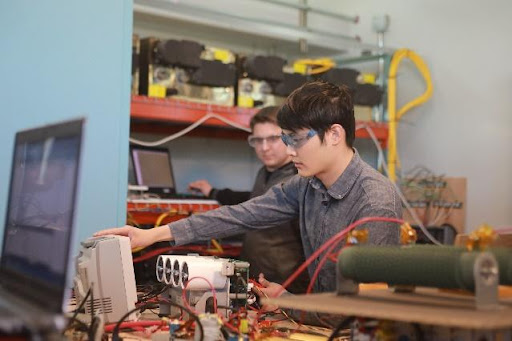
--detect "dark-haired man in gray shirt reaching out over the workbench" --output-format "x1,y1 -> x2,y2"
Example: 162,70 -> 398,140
98,81 -> 402,296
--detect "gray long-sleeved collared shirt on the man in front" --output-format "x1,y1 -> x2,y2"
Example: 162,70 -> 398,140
169,151 -> 402,292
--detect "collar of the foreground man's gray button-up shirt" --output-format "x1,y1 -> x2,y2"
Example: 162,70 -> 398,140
309,148 -> 363,200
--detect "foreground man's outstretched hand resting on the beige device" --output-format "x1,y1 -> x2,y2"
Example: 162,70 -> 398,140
94,225 -> 172,249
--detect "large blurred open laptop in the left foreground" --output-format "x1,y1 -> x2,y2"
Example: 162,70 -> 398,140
0,119 -> 84,339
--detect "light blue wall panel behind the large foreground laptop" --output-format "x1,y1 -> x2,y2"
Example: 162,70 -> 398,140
0,0 -> 133,245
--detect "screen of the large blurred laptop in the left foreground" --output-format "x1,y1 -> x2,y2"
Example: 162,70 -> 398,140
1,120 -> 83,311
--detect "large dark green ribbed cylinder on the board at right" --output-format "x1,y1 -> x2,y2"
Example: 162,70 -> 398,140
338,245 -> 512,290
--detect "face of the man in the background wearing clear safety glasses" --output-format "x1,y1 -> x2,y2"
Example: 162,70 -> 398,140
252,122 -> 291,171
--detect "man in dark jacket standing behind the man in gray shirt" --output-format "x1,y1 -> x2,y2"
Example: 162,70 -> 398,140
188,106 -> 308,293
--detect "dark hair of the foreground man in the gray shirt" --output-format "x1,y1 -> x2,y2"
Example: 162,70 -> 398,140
277,81 -> 356,147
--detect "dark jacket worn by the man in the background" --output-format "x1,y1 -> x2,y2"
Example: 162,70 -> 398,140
210,163 -> 309,293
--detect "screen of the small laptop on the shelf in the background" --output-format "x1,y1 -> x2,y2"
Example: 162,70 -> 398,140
132,147 -> 175,189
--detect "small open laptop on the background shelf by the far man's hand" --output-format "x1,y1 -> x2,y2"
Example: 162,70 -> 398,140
130,146 -> 205,200
